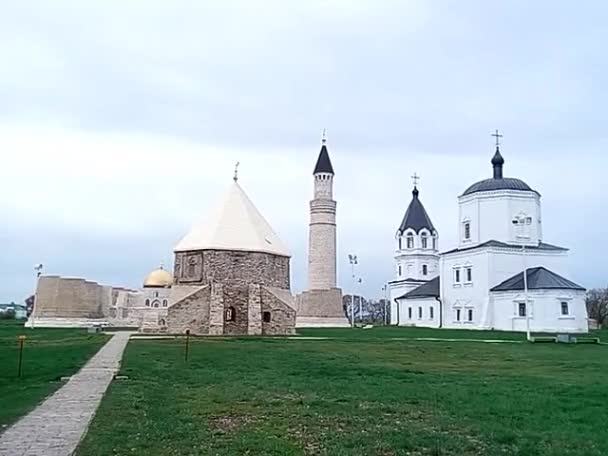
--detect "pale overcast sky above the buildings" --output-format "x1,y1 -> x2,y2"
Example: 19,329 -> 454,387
0,0 -> 608,301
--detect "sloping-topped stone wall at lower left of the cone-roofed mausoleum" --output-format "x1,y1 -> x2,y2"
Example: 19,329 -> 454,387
166,286 -> 211,334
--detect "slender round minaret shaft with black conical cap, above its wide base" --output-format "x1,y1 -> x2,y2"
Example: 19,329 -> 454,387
308,132 -> 336,290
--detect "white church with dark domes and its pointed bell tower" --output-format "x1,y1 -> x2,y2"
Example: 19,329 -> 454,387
389,145 -> 588,332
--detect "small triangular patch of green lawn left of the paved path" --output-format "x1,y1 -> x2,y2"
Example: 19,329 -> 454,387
0,320 -> 108,432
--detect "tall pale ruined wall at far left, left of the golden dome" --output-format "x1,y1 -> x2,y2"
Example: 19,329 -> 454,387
34,276 -> 107,318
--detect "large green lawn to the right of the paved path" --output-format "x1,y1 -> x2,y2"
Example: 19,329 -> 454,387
78,328 -> 608,456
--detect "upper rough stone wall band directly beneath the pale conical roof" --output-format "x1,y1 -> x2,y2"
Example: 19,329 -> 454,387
174,250 -> 290,289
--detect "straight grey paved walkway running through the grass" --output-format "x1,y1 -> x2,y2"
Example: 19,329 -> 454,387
0,332 -> 131,456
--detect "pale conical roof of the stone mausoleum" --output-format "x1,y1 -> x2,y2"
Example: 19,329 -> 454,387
175,181 -> 290,256
